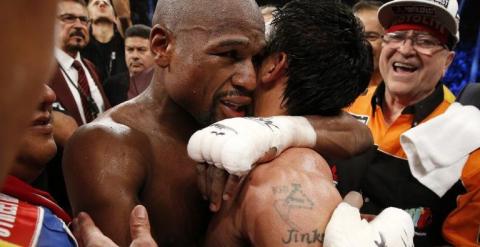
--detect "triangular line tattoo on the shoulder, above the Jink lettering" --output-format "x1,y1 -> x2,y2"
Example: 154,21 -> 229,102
272,184 -> 314,229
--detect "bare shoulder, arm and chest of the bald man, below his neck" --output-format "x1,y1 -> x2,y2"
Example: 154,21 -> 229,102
65,96 -> 207,246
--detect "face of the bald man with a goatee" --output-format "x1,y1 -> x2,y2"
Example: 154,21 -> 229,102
153,1 -> 265,124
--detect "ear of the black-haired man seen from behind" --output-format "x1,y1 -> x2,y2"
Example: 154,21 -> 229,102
259,52 -> 288,84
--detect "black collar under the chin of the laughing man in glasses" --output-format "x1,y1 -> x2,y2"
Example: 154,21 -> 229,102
371,81 -> 444,127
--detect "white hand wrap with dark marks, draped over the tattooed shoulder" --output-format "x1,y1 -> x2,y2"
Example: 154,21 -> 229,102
187,116 -> 317,176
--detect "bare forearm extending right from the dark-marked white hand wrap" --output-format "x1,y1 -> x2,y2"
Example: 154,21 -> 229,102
307,111 -> 373,159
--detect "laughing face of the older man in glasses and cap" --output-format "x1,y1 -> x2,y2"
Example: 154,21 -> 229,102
379,31 -> 454,105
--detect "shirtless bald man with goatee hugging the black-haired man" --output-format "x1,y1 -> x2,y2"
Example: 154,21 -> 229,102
63,0 -> 370,246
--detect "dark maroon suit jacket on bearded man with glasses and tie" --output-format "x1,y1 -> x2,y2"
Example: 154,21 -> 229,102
49,59 -> 110,126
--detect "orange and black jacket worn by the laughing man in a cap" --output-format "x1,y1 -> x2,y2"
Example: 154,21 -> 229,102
332,83 -> 480,246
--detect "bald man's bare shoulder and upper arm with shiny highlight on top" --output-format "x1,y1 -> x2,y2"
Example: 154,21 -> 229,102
63,124 -> 147,246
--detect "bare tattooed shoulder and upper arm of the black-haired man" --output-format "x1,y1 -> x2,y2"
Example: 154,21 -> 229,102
206,148 -> 342,247
